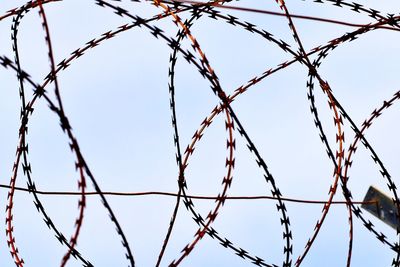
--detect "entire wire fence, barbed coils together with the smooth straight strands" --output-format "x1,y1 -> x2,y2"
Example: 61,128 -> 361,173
0,0 -> 400,267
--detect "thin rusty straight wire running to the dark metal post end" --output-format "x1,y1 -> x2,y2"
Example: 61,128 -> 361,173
0,184 -> 377,205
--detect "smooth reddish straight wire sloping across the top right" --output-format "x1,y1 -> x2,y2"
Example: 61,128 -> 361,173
170,0 -> 400,31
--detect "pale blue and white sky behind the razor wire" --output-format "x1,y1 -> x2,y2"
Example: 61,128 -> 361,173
0,0 -> 400,267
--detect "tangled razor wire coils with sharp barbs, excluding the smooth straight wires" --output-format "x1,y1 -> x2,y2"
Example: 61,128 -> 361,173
0,0 -> 400,267
